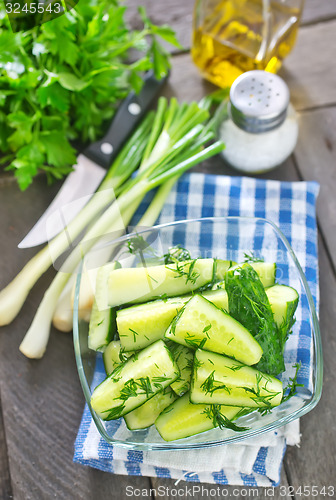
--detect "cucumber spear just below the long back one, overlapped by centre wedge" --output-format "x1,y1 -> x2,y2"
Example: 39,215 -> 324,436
117,290 -> 228,351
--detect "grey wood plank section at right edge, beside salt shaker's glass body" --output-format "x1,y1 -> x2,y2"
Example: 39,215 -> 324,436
295,108 -> 336,268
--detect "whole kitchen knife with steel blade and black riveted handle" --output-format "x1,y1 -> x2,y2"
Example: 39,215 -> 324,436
18,72 -> 167,248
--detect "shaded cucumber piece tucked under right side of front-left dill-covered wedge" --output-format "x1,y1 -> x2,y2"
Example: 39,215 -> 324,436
124,387 -> 177,431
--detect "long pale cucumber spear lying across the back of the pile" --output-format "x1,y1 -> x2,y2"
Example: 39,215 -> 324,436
108,259 -> 230,307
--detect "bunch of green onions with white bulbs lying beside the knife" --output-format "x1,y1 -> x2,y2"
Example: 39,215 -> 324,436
0,98 -> 224,358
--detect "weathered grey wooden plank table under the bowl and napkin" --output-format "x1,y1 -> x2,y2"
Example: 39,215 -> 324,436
0,0 -> 336,500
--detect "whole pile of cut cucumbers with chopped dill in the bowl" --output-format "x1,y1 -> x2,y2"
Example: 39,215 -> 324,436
88,247 -> 299,441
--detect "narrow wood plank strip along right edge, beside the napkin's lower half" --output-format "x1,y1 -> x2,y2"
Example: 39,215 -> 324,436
286,234 -> 336,492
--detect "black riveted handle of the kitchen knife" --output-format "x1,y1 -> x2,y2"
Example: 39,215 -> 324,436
83,71 -> 167,169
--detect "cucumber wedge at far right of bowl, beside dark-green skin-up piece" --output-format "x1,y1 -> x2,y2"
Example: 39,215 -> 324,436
266,285 -> 299,346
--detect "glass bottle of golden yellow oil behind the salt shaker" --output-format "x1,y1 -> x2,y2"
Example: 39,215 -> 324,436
192,0 -> 303,87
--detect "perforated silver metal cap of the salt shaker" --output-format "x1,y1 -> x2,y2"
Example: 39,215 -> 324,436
229,70 -> 289,134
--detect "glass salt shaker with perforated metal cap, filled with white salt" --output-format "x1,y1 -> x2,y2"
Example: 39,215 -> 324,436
219,70 -> 298,174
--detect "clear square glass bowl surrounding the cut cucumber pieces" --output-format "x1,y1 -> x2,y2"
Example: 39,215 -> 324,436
73,217 -> 323,450
